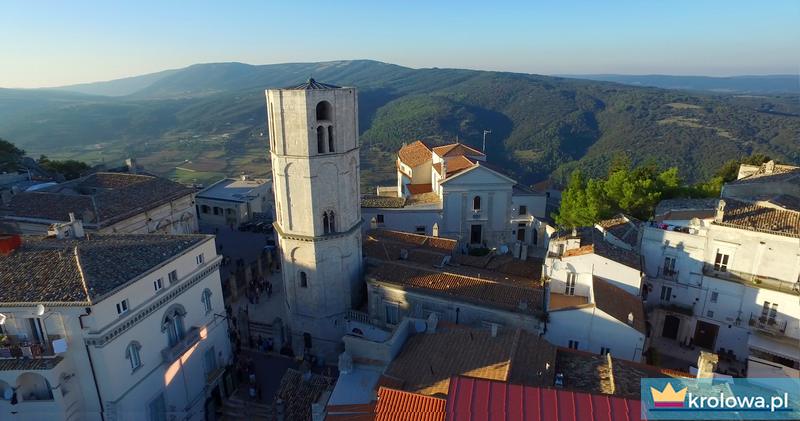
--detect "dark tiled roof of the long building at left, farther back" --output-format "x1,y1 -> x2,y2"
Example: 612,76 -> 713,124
0,172 -> 194,227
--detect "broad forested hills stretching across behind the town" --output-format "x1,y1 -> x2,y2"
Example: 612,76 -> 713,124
0,60 -> 800,186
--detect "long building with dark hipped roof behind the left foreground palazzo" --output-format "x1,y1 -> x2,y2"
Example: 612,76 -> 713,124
0,172 -> 198,235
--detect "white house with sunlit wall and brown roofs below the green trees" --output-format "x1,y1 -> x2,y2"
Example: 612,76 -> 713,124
544,215 -> 647,361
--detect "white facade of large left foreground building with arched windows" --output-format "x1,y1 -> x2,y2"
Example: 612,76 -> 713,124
0,237 -> 231,420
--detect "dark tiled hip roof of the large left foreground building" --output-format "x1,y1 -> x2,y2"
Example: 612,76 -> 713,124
0,234 -> 213,304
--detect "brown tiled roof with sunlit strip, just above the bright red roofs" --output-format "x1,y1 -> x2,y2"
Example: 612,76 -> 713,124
386,327 -> 555,395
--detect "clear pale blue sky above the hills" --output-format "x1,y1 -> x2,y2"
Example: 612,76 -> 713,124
0,0 -> 800,87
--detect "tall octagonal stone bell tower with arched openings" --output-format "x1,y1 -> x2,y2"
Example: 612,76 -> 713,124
266,79 -> 362,357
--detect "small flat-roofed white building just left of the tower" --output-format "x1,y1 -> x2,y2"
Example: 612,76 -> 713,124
195,175 -> 274,227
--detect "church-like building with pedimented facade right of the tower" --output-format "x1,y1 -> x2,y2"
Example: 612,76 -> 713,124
362,140 -> 552,254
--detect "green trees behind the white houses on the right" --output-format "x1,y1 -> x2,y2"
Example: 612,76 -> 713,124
553,154 -> 769,227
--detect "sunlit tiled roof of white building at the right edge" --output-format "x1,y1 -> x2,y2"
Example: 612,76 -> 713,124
715,199 -> 800,237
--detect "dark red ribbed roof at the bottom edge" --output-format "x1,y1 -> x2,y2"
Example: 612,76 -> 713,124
446,377 -> 641,421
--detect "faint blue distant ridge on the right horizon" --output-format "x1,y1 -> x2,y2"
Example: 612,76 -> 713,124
563,75 -> 800,94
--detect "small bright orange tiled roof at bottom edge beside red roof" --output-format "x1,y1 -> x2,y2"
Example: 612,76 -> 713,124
375,387 -> 447,421
